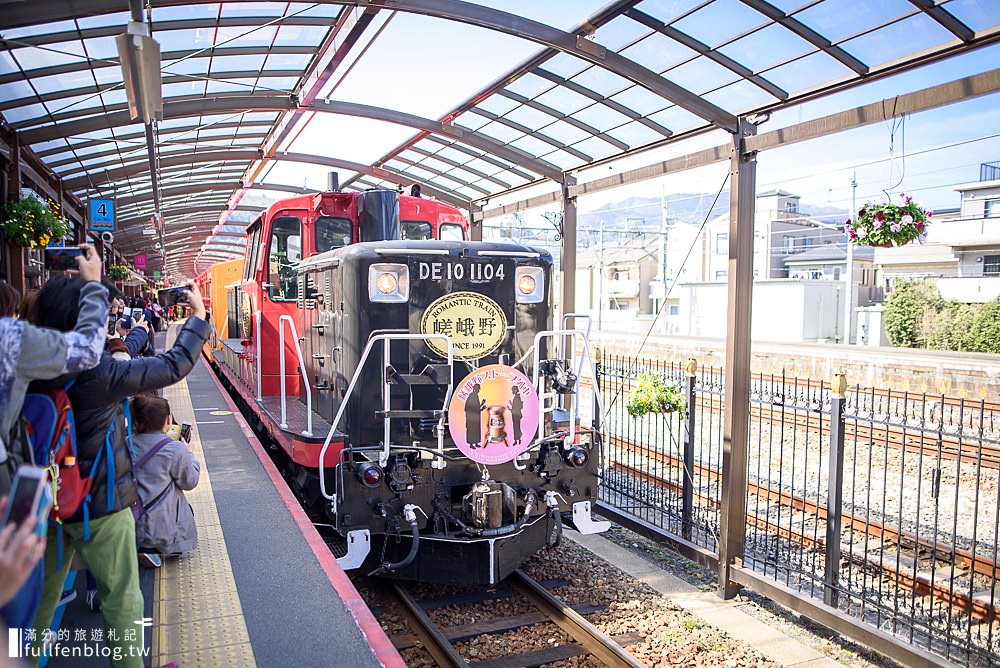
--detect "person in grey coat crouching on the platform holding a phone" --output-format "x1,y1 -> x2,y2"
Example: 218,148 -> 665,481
132,395 -> 201,568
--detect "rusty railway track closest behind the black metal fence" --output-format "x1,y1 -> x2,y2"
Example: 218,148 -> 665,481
609,437 -> 1000,622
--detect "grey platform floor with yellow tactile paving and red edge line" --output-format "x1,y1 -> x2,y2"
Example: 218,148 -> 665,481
42,332 -> 404,668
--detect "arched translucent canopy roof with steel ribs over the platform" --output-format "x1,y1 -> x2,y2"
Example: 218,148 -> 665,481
0,0 -> 1000,277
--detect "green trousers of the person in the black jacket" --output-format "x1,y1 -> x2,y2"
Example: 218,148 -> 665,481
31,508 -> 145,668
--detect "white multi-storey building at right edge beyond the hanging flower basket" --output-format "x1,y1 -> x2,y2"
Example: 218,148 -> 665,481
875,171 -> 1000,304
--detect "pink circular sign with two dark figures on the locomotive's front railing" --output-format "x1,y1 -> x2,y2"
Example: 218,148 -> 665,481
448,364 -> 538,464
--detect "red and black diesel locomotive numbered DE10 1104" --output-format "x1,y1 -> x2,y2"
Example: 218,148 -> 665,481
199,181 -> 607,584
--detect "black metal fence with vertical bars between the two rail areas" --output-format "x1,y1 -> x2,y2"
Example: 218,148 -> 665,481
597,355 -> 1000,665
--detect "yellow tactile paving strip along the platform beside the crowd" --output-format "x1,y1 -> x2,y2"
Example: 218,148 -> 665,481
152,366 -> 257,668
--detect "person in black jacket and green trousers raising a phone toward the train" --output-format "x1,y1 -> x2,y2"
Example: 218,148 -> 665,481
28,279 -> 210,668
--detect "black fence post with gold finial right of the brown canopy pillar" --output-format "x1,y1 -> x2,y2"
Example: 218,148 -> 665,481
823,371 -> 847,607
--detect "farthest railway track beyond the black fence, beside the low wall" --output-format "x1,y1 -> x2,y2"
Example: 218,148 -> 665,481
583,381 -> 1000,470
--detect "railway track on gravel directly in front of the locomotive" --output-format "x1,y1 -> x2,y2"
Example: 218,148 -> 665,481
384,569 -> 643,668
